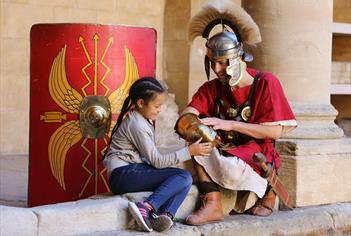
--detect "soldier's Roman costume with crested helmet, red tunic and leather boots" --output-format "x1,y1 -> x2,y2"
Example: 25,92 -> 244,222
176,1 -> 296,225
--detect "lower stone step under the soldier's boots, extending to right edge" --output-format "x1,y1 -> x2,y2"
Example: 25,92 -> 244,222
74,203 -> 351,236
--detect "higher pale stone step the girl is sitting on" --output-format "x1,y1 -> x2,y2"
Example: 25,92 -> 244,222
0,185 -> 198,236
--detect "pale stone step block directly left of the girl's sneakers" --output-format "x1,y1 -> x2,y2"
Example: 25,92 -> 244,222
32,196 -> 129,235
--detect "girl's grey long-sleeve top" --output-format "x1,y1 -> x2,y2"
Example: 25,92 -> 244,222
104,110 -> 191,174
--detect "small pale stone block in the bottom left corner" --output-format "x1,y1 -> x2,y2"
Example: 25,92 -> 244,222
0,205 -> 38,236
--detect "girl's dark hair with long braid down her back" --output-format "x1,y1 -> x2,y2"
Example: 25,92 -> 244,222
104,77 -> 165,158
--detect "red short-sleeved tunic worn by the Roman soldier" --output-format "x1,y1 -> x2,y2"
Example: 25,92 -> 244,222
189,68 -> 296,173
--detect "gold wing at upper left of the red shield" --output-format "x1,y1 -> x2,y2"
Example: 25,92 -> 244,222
49,45 -> 83,114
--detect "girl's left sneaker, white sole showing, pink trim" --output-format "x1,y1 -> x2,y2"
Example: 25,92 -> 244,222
128,202 -> 152,232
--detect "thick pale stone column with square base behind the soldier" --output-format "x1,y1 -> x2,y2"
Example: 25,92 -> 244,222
242,0 -> 351,207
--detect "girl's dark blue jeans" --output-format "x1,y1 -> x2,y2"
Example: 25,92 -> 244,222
109,163 -> 192,216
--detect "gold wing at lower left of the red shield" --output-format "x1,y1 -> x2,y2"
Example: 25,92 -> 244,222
48,120 -> 83,190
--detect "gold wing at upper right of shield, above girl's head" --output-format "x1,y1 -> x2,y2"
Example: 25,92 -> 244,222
108,46 -> 139,114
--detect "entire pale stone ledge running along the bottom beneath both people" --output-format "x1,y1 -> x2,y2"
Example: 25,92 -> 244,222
0,186 -> 351,236
